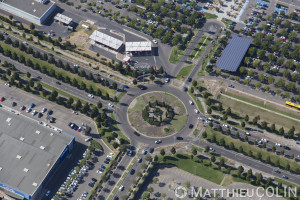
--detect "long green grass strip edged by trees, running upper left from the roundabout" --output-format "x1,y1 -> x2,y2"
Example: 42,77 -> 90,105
0,42 -> 116,96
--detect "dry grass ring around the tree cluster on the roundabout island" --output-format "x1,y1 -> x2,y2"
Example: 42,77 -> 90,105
128,92 -> 187,137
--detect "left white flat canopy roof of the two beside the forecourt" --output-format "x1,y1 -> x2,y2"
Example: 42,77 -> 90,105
90,30 -> 123,50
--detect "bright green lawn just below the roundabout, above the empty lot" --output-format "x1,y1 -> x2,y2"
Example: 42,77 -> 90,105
158,153 -> 224,185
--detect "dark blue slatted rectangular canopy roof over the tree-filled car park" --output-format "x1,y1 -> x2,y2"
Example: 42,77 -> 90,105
216,36 -> 252,72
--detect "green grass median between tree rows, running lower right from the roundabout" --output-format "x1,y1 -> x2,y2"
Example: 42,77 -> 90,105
206,127 -> 299,171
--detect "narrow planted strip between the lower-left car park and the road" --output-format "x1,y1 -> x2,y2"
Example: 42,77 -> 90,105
86,151 -> 124,199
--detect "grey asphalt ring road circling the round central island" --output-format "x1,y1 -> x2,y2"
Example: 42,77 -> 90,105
115,84 -> 201,146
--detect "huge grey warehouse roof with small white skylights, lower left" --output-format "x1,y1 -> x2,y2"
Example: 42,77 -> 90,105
0,107 -> 74,195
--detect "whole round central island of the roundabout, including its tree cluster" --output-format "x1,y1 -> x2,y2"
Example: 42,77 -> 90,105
128,92 -> 187,137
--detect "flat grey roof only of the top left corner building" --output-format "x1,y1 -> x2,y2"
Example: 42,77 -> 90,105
0,0 -> 55,18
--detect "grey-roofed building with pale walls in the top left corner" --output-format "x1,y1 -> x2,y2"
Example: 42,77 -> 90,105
0,0 -> 56,24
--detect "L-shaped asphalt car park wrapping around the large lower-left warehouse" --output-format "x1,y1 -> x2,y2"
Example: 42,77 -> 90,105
0,81 -> 111,199
